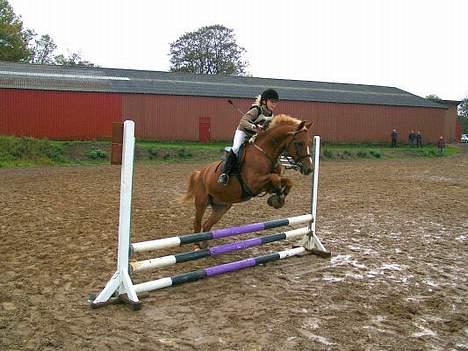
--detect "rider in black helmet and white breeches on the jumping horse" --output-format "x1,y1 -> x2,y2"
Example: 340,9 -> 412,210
218,89 -> 279,185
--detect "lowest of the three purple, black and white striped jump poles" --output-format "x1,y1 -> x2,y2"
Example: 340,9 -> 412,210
134,247 -> 306,294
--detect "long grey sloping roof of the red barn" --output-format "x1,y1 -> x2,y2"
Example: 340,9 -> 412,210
0,61 -> 447,108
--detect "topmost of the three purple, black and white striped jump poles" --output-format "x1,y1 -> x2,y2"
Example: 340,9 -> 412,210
131,214 -> 313,253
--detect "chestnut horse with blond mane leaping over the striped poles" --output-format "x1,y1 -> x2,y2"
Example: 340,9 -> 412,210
182,114 -> 313,248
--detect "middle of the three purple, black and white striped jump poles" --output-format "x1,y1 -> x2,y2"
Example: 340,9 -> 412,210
130,227 -> 309,273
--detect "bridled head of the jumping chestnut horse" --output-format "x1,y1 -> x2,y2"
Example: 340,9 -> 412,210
286,121 -> 313,175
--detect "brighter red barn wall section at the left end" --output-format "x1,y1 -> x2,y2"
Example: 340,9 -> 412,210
0,89 -> 122,140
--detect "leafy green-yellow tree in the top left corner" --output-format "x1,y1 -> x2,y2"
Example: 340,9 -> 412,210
0,0 -> 32,62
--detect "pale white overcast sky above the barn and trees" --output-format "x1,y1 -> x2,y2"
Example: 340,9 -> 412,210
9,0 -> 468,100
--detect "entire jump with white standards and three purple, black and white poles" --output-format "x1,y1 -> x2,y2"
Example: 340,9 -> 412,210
89,121 -> 331,309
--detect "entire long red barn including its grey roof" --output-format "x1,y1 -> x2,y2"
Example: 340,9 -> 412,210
0,62 -> 456,143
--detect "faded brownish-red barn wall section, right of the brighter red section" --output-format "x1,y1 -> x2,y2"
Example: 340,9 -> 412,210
122,94 -> 449,143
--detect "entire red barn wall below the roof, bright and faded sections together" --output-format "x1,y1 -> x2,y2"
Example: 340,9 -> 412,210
0,89 -> 448,143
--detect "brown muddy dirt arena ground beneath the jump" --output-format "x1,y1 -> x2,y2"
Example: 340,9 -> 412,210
0,152 -> 468,351
